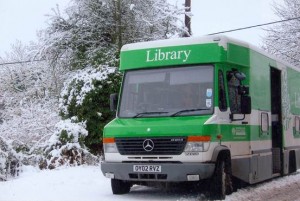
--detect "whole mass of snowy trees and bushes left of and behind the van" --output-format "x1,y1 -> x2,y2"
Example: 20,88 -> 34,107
0,0 -> 185,170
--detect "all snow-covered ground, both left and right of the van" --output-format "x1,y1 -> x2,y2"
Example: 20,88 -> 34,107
0,166 -> 300,201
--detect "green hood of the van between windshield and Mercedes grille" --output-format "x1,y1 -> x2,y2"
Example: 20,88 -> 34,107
104,115 -> 210,137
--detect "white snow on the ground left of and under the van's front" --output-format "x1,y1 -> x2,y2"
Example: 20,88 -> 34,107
0,166 -> 199,201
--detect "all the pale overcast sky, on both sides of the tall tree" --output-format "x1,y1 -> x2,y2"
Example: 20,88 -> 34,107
0,0 -> 282,56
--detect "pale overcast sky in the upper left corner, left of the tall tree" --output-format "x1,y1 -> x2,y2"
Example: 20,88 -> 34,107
0,0 -> 69,57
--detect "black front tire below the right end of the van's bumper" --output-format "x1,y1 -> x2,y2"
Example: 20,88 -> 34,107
210,159 -> 233,200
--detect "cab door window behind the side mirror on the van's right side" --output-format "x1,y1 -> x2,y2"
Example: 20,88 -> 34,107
227,71 -> 241,114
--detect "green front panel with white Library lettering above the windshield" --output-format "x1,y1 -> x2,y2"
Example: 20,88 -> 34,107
120,43 -> 226,71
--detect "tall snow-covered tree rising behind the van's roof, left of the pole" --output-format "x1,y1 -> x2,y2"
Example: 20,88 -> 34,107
40,0 -> 185,69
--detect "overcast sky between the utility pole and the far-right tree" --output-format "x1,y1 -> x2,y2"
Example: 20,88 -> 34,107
192,0 -> 282,46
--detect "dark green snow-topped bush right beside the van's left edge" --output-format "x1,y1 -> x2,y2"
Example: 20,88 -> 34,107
59,66 -> 121,154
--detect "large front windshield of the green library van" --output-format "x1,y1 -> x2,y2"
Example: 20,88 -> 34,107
119,66 -> 214,118
